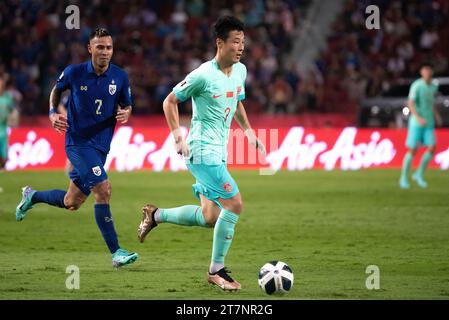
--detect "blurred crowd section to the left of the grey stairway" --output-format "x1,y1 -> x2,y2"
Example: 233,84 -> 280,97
0,0 -> 304,115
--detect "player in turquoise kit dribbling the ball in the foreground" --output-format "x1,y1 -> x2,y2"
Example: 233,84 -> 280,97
138,16 -> 265,291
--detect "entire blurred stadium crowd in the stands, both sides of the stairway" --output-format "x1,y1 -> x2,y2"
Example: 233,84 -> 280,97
0,0 -> 449,115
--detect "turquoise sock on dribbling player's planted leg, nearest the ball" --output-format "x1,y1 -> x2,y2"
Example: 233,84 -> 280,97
211,209 -> 239,272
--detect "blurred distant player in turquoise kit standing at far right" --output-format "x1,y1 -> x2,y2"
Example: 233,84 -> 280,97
399,64 -> 442,189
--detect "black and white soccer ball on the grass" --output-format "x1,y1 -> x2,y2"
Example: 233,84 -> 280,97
259,261 -> 293,294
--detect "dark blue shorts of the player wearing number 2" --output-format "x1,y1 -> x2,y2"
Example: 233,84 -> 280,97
65,146 -> 108,196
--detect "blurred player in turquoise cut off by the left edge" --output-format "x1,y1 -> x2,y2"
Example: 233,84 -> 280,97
0,75 -> 19,179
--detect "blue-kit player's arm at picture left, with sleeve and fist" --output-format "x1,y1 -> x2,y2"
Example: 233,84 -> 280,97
48,66 -> 72,133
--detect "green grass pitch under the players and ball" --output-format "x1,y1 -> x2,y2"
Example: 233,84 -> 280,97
0,170 -> 449,300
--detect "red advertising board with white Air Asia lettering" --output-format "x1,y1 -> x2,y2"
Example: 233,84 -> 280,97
6,126 -> 449,171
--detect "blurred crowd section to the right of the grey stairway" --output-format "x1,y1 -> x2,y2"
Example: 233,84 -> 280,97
310,0 -> 449,112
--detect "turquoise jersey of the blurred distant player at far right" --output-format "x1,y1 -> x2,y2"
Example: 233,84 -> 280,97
408,78 -> 438,128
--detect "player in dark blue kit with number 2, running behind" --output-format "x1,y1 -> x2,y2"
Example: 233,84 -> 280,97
16,28 -> 139,268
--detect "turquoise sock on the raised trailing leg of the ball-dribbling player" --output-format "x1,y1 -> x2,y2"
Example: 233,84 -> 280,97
156,205 -> 209,227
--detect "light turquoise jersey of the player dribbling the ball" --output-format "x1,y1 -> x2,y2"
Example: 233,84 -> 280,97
173,59 -> 246,165
